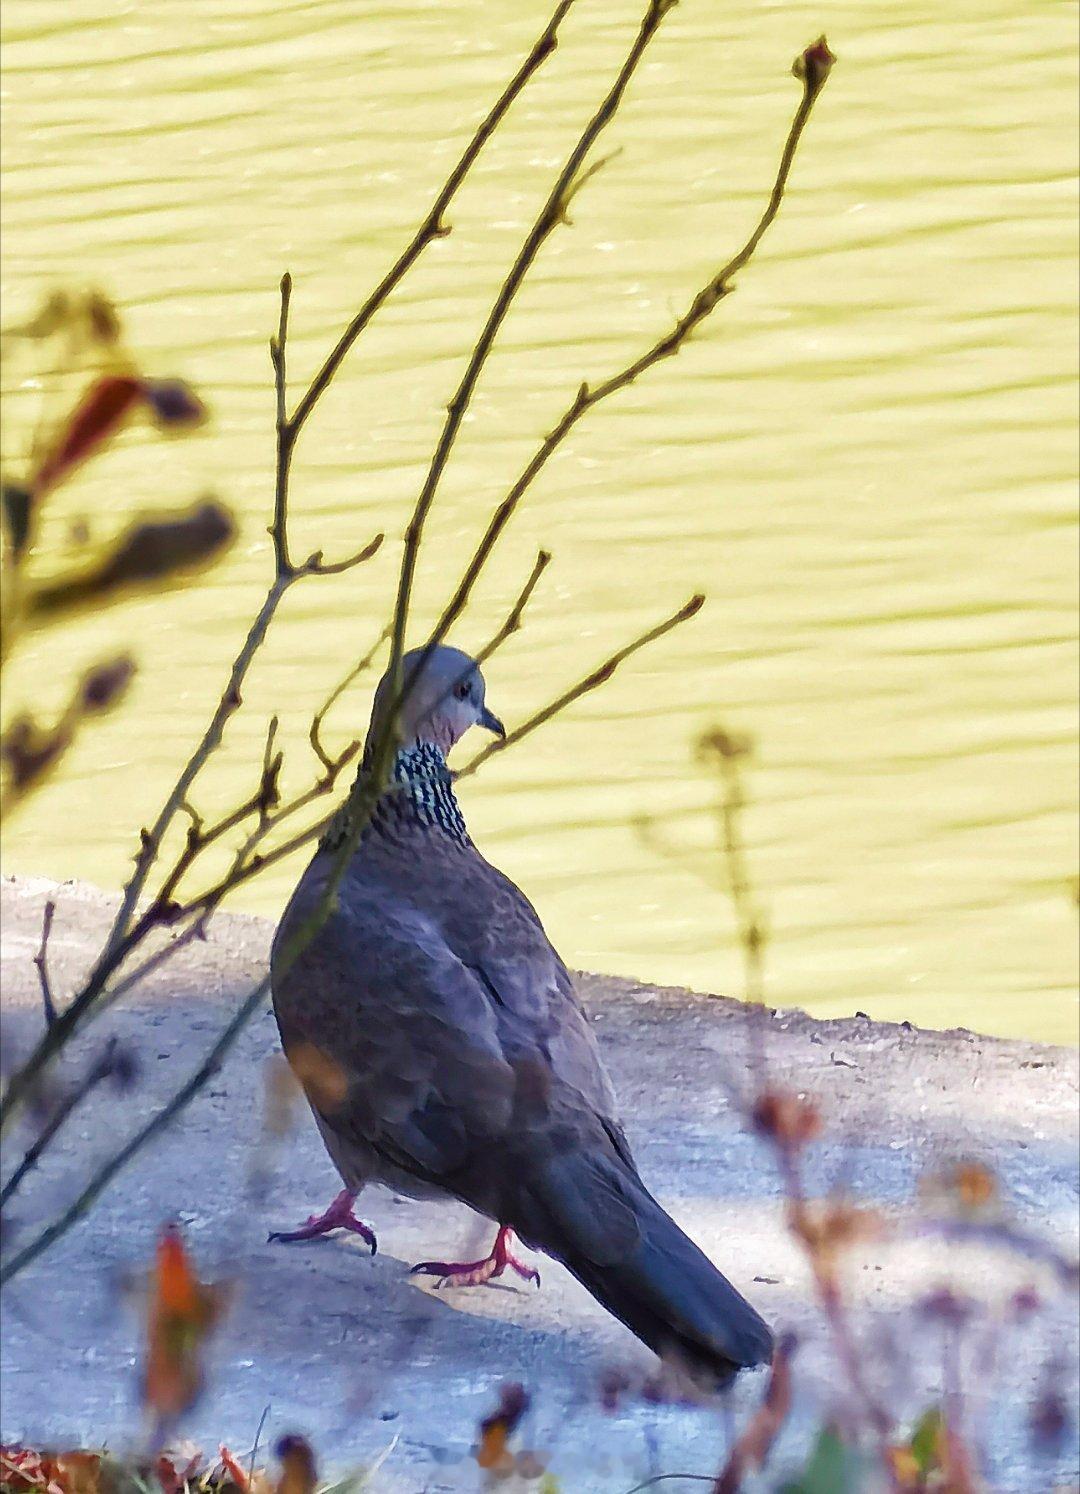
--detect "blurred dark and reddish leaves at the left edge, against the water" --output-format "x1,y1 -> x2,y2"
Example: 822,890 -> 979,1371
0,291 -> 236,813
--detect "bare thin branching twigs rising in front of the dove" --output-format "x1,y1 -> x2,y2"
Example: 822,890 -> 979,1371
0,0 -> 832,1282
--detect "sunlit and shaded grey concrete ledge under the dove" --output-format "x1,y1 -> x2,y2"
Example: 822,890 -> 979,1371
0,878 -> 1077,1494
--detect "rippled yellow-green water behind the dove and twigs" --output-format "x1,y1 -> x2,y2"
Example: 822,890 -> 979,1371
3,0 -> 1079,1040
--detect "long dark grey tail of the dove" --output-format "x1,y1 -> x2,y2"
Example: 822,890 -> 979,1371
517,1152 -> 774,1386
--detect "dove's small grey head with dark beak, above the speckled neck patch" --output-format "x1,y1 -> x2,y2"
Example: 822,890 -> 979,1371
367,644 -> 506,756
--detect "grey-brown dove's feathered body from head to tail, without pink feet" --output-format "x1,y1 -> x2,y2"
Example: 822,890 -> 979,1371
272,647 -> 772,1382
